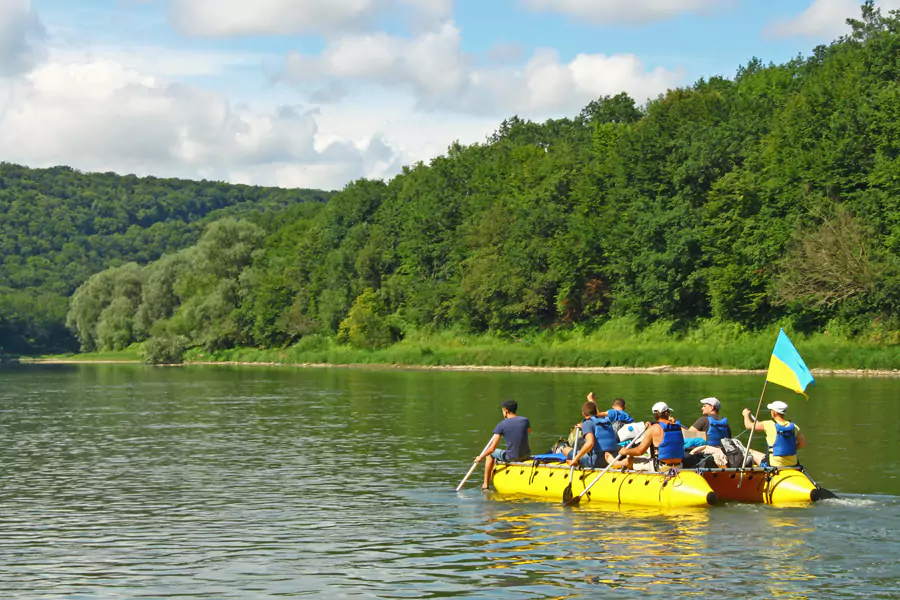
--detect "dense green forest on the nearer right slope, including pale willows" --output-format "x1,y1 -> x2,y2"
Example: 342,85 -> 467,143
45,2 -> 900,361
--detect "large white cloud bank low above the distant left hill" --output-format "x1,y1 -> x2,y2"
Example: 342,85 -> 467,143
0,59 -> 398,188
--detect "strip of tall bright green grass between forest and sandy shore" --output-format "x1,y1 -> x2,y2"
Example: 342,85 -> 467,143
185,319 -> 900,370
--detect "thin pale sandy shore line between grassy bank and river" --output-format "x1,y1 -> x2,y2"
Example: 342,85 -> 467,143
19,358 -> 900,377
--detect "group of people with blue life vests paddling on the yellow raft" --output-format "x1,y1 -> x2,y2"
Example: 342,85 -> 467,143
475,392 -> 806,490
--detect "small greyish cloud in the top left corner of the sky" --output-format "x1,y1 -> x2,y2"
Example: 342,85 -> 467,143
0,0 -> 44,78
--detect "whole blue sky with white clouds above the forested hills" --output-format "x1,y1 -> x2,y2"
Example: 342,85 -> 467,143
0,0 -> 900,189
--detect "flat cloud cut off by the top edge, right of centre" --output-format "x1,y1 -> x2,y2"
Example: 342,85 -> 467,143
519,0 -> 724,24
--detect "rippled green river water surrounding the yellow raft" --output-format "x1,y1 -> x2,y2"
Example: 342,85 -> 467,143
0,365 -> 900,600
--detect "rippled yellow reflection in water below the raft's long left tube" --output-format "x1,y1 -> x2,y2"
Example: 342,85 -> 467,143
478,496 -> 709,592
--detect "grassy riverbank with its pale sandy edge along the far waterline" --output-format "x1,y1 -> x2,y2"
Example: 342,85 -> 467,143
23,325 -> 900,377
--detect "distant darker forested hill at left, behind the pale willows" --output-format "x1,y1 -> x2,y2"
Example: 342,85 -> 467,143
0,163 -> 330,352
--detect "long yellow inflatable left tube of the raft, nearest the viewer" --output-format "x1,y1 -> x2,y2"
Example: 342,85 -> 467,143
493,462 -> 716,508
